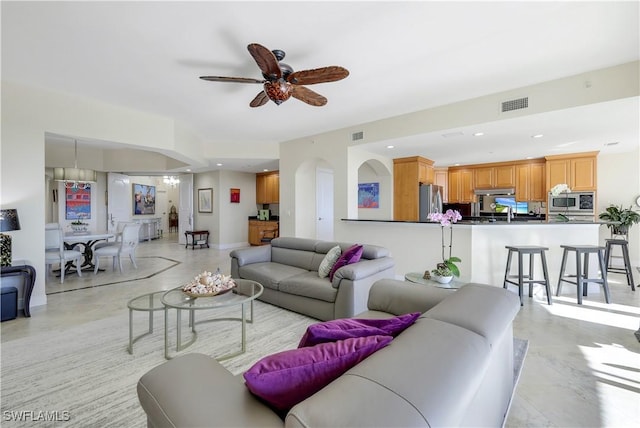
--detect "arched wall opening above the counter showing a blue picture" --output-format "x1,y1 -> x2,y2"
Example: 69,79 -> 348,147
358,159 -> 393,220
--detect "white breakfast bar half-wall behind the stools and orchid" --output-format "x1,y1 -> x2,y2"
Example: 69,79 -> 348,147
336,219 -> 602,292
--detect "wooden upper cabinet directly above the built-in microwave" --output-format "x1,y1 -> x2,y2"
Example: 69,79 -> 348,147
545,152 -> 598,191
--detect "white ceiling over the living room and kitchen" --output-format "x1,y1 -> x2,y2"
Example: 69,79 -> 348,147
2,1 -> 640,171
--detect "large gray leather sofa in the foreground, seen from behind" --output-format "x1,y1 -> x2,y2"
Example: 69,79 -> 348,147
138,280 -> 520,428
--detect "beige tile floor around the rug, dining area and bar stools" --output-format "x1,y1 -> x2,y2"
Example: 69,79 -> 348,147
0,233 -> 640,427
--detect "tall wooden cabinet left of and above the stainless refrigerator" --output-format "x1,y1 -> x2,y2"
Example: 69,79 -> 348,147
393,156 -> 434,221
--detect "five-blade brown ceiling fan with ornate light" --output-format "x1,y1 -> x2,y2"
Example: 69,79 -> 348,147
200,43 -> 349,107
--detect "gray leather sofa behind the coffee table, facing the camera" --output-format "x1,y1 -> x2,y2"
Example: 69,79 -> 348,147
230,237 -> 395,321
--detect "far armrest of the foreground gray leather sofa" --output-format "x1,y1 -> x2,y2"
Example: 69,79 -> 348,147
367,279 -> 454,315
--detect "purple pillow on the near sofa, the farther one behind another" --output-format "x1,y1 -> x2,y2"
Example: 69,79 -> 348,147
298,312 -> 421,348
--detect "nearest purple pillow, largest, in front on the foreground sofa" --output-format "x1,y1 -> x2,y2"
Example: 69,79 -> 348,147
243,336 -> 393,412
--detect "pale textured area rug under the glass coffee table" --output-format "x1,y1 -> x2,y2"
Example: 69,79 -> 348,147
1,301 -> 528,428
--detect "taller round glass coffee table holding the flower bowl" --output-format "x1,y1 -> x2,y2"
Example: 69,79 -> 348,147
161,278 -> 264,361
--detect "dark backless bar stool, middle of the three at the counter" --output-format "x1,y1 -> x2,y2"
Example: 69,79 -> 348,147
556,245 -> 609,305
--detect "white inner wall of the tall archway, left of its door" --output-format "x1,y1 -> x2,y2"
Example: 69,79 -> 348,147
294,158 -> 334,239
